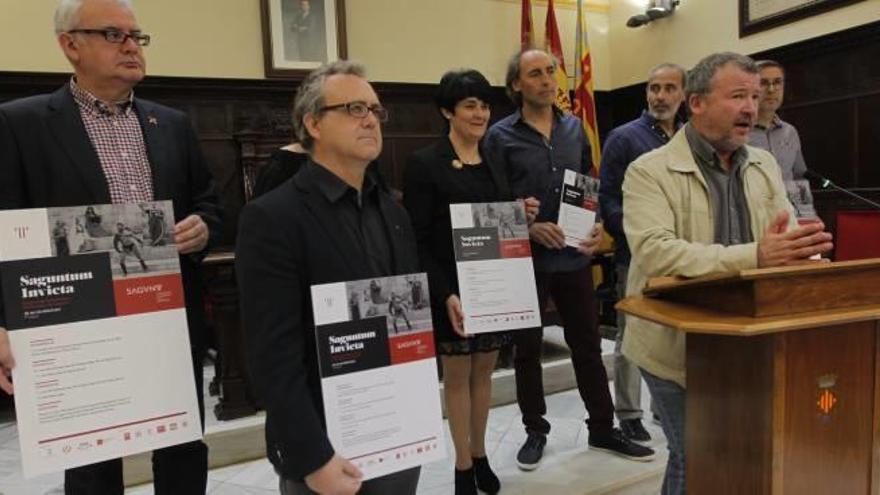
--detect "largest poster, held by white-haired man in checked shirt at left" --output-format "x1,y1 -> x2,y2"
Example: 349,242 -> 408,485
0,201 -> 202,477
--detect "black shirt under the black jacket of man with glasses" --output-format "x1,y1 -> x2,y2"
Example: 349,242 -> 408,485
306,162 -> 393,277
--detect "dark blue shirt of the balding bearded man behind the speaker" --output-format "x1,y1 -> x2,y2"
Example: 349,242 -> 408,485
599,111 -> 681,266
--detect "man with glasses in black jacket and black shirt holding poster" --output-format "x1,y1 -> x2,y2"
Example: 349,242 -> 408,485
236,62 -> 419,495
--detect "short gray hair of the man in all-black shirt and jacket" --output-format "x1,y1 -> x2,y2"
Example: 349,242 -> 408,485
293,60 -> 367,151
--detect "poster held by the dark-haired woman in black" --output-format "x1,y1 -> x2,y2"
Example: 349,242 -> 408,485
449,201 -> 541,334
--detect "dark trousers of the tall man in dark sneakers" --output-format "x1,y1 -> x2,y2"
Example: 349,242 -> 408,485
513,267 -> 614,436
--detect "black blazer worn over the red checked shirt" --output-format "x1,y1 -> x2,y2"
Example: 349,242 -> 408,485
0,86 -> 220,349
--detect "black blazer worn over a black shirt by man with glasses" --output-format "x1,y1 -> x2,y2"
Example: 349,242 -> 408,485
235,161 -> 418,480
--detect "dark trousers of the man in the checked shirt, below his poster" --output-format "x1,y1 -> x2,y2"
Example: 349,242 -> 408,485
64,350 -> 208,495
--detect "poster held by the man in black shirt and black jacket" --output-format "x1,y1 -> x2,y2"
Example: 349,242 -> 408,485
312,273 -> 446,479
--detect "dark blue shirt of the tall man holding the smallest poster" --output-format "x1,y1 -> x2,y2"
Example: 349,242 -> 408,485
483,108 -> 592,272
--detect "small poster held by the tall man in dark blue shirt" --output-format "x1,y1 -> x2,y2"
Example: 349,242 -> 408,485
556,170 -> 599,248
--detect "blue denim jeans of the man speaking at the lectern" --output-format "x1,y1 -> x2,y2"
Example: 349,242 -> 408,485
642,369 -> 686,495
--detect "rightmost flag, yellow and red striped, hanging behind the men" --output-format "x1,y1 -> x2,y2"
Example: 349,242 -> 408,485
573,0 -> 602,170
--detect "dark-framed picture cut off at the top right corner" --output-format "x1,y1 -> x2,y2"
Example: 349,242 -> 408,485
739,0 -> 864,38
